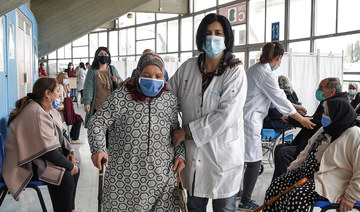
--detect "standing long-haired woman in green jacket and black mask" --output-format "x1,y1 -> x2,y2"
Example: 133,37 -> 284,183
83,47 -> 122,128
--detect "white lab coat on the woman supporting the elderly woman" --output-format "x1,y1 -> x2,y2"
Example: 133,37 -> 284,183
169,58 -> 247,199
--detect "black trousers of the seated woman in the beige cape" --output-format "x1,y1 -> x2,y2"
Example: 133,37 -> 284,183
48,169 -> 80,212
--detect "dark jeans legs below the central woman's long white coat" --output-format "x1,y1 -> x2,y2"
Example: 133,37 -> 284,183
187,194 -> 236,212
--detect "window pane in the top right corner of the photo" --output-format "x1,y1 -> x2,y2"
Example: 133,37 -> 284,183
338,0 -> 360,32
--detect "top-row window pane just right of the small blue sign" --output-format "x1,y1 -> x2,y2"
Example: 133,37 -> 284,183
289,0 -> 311,39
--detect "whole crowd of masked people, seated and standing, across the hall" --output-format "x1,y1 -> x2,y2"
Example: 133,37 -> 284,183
3,13 -> 360,212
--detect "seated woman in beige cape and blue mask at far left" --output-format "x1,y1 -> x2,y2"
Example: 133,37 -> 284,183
2,77 -> 79,212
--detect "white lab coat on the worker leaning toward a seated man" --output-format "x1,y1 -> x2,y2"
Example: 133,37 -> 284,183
244,63 -> 296,162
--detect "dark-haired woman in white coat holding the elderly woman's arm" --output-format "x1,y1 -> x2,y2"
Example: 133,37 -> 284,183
169,13 -> 247,212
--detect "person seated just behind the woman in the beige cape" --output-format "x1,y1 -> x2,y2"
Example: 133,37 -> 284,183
57,73 -> 82,143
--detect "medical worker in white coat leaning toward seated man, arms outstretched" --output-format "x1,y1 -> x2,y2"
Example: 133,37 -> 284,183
238,42 -> 315,210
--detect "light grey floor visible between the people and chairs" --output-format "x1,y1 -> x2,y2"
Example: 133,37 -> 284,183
0,106 -> 324,212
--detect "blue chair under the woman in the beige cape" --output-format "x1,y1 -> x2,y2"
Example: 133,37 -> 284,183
0,131 -> 47,212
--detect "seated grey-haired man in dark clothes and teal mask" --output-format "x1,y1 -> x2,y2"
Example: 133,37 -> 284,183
272,77 -> 347,180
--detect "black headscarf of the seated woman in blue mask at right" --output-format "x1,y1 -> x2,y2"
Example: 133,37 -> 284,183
324,97 -> 356,142
